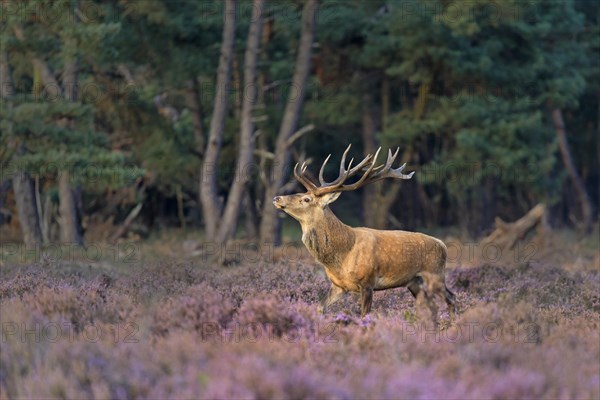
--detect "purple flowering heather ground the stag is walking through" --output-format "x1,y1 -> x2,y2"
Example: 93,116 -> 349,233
0,227 -> 600,399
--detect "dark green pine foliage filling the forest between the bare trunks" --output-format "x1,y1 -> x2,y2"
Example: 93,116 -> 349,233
0,0 -> 600,233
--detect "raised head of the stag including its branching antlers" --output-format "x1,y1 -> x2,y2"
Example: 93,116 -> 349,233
273,145 -> 414,223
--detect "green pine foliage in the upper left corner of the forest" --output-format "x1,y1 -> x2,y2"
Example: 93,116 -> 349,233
1,1 -> 143,191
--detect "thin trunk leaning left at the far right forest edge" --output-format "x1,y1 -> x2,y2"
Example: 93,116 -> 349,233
552,108 -> 593,233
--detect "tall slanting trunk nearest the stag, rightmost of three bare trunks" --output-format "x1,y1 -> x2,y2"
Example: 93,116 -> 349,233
260,0 -> 318,244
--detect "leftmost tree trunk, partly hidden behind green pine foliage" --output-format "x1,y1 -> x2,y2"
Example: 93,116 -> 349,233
0,51 -> 42,247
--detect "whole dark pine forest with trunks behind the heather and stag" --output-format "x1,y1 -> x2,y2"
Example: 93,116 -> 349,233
0,0 -> 600,250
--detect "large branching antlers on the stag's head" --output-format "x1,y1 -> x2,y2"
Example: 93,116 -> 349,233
294,145 -> 414,196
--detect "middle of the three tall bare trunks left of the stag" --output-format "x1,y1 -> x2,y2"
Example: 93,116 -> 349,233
216,0 -> 264,245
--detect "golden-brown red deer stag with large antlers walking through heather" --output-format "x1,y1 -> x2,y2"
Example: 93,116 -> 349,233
273,146 -> 455,320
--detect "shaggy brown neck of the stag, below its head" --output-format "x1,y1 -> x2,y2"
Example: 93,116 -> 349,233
302,207 -> 355,268
